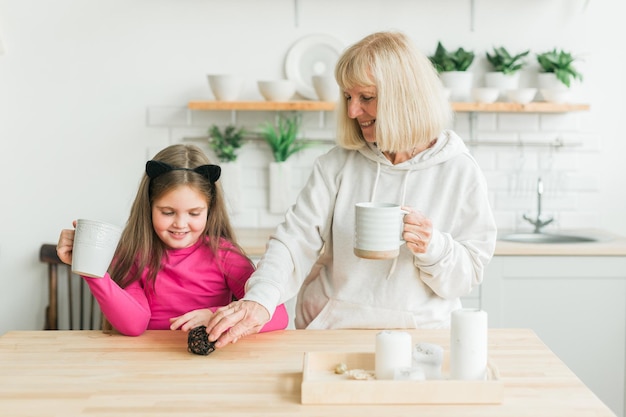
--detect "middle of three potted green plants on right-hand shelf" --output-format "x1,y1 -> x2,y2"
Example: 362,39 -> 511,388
485,46 -> 530,94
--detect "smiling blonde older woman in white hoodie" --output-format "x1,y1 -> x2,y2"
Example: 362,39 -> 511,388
207,32 -> 496,347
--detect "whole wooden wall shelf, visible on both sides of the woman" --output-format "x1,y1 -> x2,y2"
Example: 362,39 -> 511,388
188,100 -> 589,113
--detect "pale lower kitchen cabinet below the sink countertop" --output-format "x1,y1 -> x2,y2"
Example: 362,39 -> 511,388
481,256 -> 626,417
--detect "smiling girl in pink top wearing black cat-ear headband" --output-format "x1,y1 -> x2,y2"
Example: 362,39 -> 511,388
57,145 -> 288,336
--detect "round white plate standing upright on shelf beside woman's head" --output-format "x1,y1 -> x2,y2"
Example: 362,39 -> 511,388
285,35 -> 344,100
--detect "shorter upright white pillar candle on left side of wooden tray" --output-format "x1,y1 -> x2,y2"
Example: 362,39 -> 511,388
375,330 -> 413,379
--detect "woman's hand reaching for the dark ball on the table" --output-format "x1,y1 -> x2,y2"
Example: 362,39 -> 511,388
207,300 -> 271,348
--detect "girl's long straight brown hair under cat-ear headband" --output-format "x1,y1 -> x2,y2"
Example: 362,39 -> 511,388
110,144 -> 243,288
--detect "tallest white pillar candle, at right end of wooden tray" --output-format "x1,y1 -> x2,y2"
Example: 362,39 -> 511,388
450,308 -> 487,380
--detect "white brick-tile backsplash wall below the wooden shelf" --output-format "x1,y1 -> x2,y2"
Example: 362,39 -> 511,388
146,106 -> 600,230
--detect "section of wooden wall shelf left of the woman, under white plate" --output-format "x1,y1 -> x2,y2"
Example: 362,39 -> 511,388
188,100 -> 335,111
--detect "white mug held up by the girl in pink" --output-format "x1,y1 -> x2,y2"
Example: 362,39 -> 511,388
72,219 -> 122,278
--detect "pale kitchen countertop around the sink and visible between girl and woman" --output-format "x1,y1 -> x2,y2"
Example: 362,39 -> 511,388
235,228 -> 626,258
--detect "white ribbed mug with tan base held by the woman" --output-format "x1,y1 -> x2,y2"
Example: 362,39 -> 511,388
354,203 -> 408,259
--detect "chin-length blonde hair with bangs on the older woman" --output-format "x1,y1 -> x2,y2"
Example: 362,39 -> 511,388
335,32 -> 452,153
